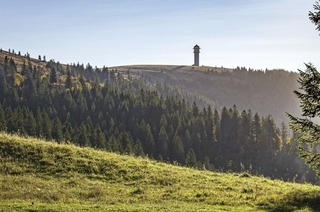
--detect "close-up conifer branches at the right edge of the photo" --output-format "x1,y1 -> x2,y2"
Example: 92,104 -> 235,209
289,1 -> 320,176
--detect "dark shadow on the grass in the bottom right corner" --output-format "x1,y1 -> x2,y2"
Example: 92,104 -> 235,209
264,191 -> 320,212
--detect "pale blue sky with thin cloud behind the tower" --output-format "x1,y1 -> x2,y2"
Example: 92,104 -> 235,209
0,0 -> 320,71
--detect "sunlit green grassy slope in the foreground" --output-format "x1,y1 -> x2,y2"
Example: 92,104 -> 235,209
0,133 -> 320,211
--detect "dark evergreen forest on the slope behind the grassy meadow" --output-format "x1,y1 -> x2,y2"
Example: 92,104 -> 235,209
0,51 -> 317,183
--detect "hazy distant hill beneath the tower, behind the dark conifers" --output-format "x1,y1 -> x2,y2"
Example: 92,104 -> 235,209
113,65 -> 301,123
